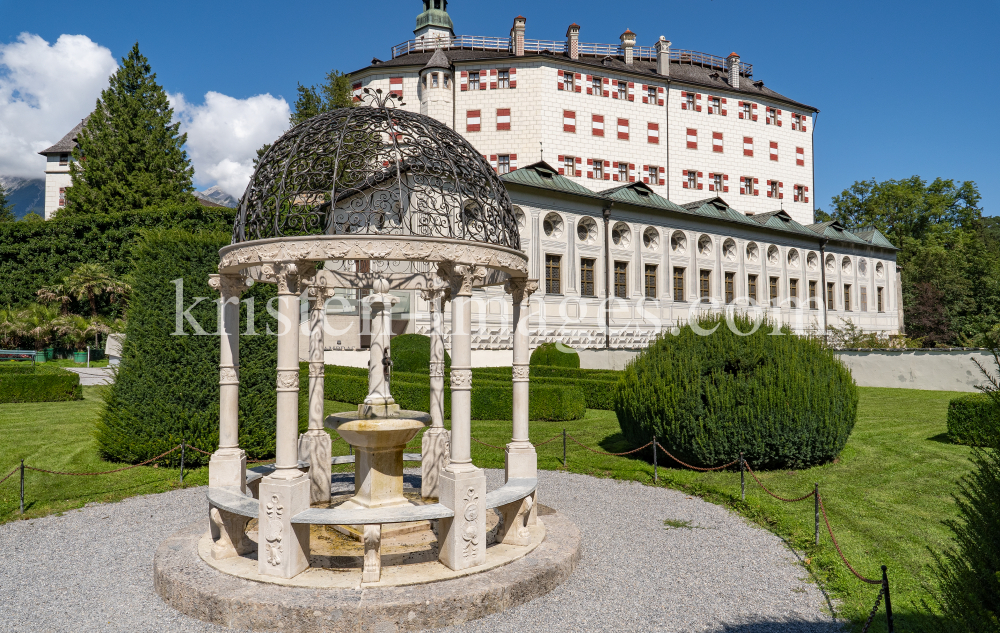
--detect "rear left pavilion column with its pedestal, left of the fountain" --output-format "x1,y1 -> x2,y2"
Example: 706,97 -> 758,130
299,278 -> 334,503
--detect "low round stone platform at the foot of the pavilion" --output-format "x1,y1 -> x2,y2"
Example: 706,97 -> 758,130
153,505 -> 581,633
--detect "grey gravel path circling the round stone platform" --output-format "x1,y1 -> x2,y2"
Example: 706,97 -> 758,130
0,471 -> 841,633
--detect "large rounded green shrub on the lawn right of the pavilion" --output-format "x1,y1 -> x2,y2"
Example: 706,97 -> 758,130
614,314 -> 858,468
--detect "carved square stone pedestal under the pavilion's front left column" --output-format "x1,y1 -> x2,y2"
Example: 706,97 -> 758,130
257,475 -> 310,578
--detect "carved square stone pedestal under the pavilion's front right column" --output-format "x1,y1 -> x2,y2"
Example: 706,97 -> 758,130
438,468 -> 486,570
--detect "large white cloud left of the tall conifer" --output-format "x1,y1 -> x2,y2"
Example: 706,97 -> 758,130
0,33 -> 118,178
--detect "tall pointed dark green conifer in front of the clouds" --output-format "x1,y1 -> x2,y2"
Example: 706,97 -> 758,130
60,43 -> 194,214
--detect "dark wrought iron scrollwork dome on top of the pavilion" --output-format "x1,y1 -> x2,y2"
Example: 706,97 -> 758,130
233,89 -> 521,250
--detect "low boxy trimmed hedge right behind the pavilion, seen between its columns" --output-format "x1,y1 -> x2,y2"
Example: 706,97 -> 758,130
324,366 -> 586,421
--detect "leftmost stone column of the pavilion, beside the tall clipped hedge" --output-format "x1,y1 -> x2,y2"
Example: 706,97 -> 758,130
208,275 -> 247,494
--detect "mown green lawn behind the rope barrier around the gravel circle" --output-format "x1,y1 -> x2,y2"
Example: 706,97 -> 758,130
0,387 -> 969,631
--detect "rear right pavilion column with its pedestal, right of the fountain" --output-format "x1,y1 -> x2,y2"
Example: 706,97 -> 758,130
420,286 -> 451,498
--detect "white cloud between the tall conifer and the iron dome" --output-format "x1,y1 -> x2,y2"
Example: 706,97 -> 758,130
170,92 -> 291,198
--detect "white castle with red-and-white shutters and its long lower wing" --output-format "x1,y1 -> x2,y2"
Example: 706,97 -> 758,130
332,0 -> 902,351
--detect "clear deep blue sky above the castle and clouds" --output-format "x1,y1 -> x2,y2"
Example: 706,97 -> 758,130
0,0 -> 1000,215
